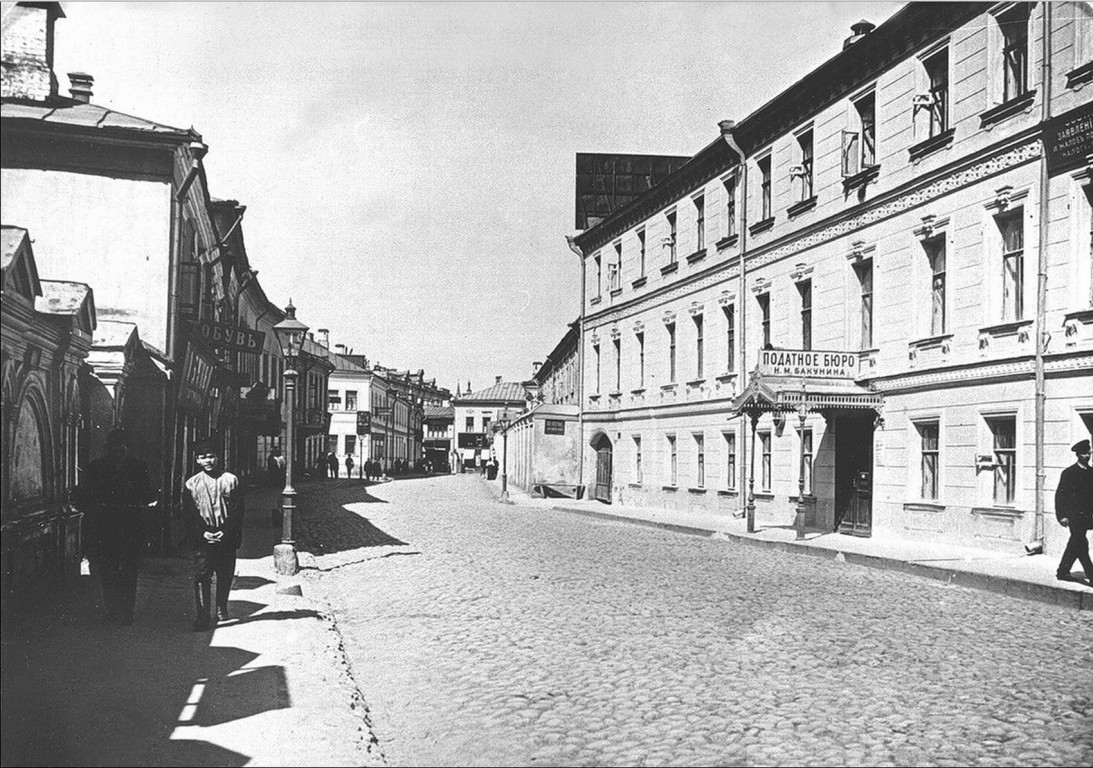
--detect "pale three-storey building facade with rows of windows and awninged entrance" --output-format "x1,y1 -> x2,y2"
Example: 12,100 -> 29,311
575,3 -> 1093,551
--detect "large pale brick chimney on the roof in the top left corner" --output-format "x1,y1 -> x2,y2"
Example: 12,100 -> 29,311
0,2 -> 64,102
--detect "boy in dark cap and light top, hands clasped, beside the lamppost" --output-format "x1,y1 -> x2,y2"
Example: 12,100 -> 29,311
183,439 -> 244,631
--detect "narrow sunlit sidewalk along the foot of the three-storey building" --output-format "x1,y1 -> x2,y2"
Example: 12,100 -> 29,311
483,478 -> 1093,611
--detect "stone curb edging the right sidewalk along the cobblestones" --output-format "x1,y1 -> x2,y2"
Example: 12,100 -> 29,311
551,506 -> 1093,611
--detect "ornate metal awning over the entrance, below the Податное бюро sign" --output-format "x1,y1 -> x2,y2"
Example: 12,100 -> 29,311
732,371 -> 884,414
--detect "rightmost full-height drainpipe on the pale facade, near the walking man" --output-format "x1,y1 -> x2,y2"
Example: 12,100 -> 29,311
1025,2 -> 1051,555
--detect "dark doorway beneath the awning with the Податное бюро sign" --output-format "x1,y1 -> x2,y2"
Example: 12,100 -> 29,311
835,412 -> 873,536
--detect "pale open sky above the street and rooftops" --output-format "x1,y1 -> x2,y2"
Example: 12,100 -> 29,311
55,2 -> 903,391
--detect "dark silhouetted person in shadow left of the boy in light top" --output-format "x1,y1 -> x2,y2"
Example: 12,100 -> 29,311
74,429 -> 155,625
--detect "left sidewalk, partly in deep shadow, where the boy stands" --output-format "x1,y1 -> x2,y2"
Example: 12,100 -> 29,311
0,483 -> 384,766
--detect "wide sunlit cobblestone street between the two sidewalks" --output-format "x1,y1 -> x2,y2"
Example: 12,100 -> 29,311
301,476 -> 1093,766
